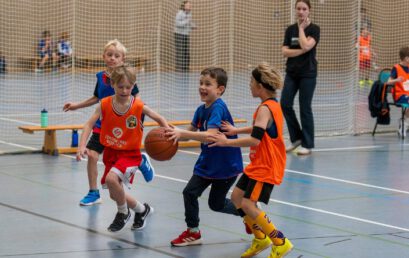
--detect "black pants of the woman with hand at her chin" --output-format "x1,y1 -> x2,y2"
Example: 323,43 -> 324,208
281,74 -> 317,149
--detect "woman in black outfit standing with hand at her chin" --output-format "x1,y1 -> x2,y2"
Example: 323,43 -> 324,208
281,0 -> 320,155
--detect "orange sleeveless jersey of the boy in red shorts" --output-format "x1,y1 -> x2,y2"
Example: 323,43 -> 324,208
100,96 -> 144,150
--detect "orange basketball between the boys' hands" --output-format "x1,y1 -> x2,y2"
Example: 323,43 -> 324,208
145,127 -> 178,161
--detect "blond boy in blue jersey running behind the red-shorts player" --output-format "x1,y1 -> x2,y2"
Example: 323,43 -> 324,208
63,39 -> 155,208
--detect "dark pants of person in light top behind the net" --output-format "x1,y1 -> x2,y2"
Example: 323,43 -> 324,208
175,33 -> 190,72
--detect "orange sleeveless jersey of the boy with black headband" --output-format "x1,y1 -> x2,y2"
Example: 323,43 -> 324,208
244,100 -> 287,185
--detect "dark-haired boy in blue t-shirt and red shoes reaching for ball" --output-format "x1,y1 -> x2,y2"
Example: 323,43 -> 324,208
166,67 -> 243,246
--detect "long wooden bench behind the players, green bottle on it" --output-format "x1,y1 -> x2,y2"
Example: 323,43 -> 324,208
18,118 -> 247,155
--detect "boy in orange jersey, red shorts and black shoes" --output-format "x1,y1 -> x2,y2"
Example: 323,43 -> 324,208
77,65 -> 168,232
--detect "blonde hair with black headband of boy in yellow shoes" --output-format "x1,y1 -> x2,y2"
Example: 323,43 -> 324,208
252,62 -> 283,92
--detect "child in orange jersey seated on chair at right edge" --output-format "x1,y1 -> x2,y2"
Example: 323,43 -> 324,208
388,47 -> 409,137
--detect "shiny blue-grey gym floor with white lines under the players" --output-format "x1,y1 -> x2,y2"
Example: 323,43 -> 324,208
0,134 -> 409,258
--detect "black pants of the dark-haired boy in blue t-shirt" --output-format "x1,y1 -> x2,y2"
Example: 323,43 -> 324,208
183,175 -> 239,228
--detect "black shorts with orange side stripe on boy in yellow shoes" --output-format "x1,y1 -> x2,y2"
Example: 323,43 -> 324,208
236,173 -> 274,204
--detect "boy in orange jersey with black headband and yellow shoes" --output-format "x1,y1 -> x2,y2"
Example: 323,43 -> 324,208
208,63 -> 293,258
